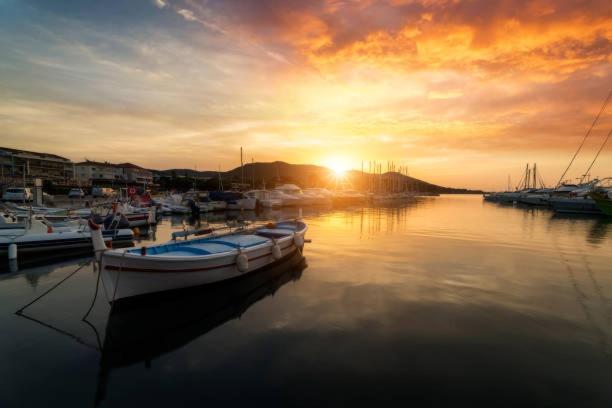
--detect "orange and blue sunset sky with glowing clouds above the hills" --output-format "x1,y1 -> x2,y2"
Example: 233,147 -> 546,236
0,0 -> 612,189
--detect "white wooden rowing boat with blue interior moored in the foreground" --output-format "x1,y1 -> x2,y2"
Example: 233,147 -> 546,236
93,221 -> 307,303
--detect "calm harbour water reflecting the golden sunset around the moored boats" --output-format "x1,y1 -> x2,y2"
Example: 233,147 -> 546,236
0,196 -> 612,407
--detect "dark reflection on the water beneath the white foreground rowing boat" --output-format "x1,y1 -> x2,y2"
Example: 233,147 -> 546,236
96,252 -> 306,403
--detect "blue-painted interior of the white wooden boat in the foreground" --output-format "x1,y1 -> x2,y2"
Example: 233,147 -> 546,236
128,222 -> 304,256
